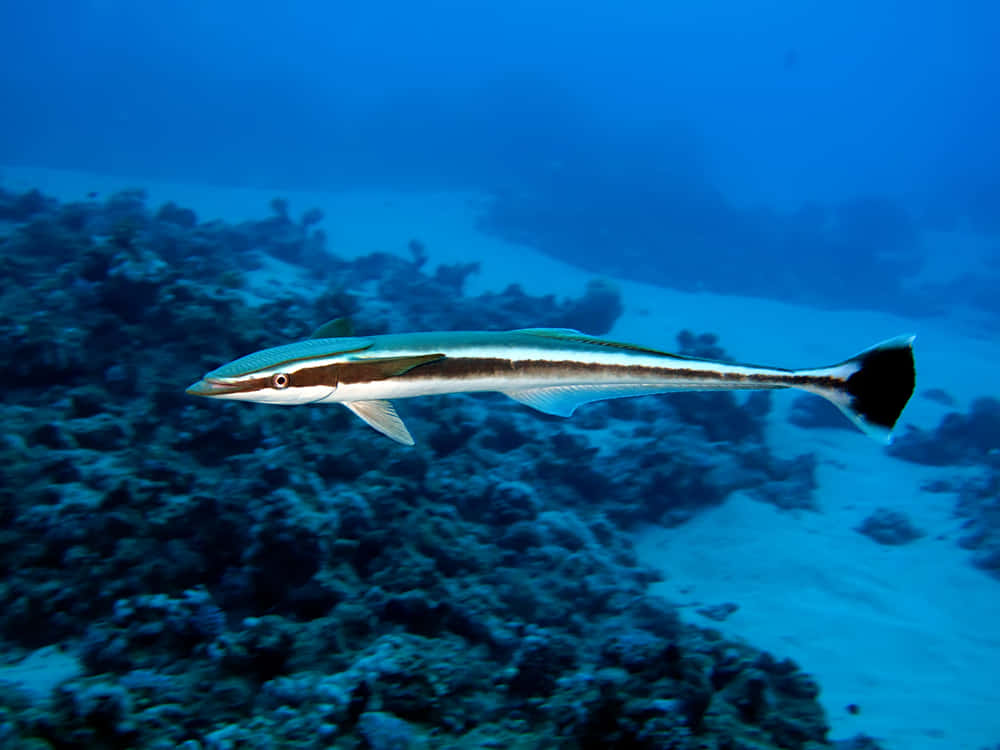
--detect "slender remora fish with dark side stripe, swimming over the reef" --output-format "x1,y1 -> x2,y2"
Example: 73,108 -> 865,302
187,321 -> 915,445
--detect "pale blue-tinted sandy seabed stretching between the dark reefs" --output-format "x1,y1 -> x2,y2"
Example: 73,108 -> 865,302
7,167 -> 1000,750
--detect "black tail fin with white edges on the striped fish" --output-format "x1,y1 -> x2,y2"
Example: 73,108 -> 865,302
799,335 -> 916,443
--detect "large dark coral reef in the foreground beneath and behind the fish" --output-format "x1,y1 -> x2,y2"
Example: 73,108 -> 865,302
0,185 -> 864,750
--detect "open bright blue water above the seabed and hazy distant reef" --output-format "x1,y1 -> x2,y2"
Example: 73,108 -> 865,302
0,0 -> 1000,206
